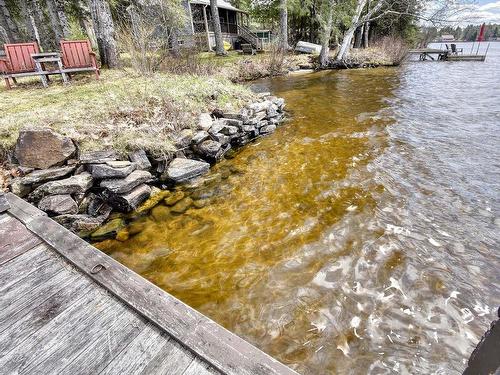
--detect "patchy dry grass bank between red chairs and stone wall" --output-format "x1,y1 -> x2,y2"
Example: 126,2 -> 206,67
0,69 -> 253,155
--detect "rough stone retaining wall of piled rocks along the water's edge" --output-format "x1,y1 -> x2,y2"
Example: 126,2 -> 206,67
4,93 -> 285,238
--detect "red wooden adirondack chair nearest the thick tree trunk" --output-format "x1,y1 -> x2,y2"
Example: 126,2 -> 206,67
61,40 -> 99,79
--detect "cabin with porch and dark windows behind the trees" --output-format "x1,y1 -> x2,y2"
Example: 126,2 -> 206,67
179,0 -> 271,51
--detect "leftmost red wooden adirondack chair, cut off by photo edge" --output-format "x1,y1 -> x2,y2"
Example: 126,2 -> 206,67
0,42 -> 40,89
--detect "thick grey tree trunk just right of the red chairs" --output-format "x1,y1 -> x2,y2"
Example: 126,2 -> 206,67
89,0 -> 118,68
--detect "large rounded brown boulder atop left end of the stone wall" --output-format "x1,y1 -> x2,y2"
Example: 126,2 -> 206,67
14,129 -> 76,169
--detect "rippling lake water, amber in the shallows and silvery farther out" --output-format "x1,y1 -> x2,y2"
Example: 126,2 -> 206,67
98,45 -> 500,374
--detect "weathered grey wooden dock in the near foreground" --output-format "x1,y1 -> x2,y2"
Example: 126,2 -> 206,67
0,192 -> 297,375
